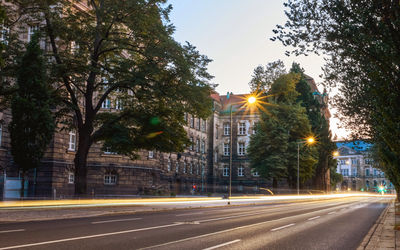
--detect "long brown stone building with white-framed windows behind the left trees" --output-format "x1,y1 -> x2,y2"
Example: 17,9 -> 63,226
0,2 -> 332,197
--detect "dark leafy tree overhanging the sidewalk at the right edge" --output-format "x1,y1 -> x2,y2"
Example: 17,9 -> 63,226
274,0 -> 400,198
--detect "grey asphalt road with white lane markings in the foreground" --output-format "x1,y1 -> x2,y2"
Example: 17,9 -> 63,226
0,197 -> 391,250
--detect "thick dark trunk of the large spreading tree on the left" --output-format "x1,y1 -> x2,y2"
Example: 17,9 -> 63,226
74,131 -> 91,196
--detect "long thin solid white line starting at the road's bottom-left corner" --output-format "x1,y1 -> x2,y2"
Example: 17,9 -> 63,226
0,223 -> 181,250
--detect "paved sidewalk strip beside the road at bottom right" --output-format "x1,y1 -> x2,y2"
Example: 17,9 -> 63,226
357,202 -> 400,250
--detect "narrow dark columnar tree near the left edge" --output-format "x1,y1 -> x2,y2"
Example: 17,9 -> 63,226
9,33 -> 55,197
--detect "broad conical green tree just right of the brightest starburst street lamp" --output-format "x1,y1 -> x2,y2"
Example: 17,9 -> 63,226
248,73 -> 316,188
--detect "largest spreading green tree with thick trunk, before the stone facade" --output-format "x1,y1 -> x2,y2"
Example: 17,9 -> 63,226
10,0 -> 211,195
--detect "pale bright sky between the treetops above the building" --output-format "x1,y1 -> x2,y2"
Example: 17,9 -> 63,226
169,0 -> 345,137
